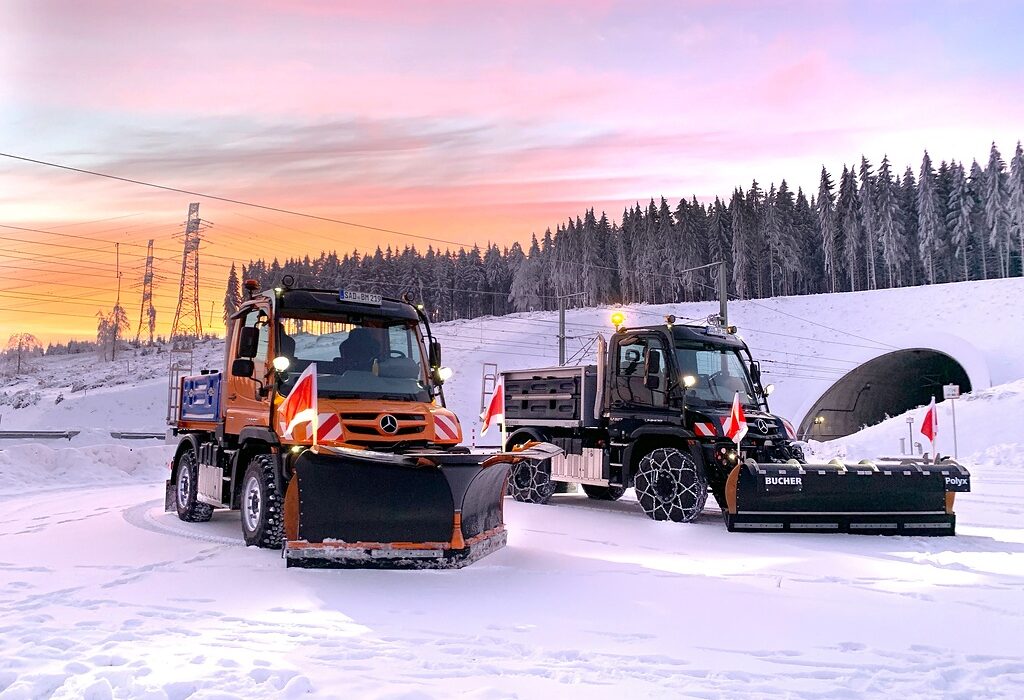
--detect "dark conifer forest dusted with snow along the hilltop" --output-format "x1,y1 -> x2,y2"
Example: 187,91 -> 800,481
230,142 -> 1024,320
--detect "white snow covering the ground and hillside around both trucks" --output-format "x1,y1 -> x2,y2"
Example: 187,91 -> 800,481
0,280 -> 1024,700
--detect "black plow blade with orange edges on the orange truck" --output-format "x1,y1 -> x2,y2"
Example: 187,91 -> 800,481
285,447 -> 561,569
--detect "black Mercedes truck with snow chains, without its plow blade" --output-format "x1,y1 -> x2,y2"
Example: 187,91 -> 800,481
504,317 -> 803,521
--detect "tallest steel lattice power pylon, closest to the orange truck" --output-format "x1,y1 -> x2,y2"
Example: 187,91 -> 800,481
167,202 -> 203,425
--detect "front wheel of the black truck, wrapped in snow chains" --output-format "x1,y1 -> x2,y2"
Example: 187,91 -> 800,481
633,447 -> 708,523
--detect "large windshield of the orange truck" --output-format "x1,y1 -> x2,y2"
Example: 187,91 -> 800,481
278,311 -> 430,401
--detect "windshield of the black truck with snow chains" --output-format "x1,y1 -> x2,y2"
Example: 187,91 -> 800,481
676,343 -> 757,406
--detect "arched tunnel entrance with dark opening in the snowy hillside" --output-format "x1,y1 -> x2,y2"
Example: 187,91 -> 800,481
799,335 -> 990,440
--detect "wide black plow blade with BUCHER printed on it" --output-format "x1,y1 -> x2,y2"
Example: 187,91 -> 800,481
723,458 -> 971,535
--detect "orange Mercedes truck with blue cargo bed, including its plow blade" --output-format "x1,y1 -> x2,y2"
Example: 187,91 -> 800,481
165,276 -> 559,568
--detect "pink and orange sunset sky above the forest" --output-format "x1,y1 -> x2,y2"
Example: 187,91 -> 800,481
0,0 -> 1024,341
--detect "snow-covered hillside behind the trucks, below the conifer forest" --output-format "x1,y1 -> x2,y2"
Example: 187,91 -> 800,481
0,277 -> 1024,452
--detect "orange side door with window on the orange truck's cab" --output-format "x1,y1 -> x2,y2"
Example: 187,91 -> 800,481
224,306 -> 272,435
